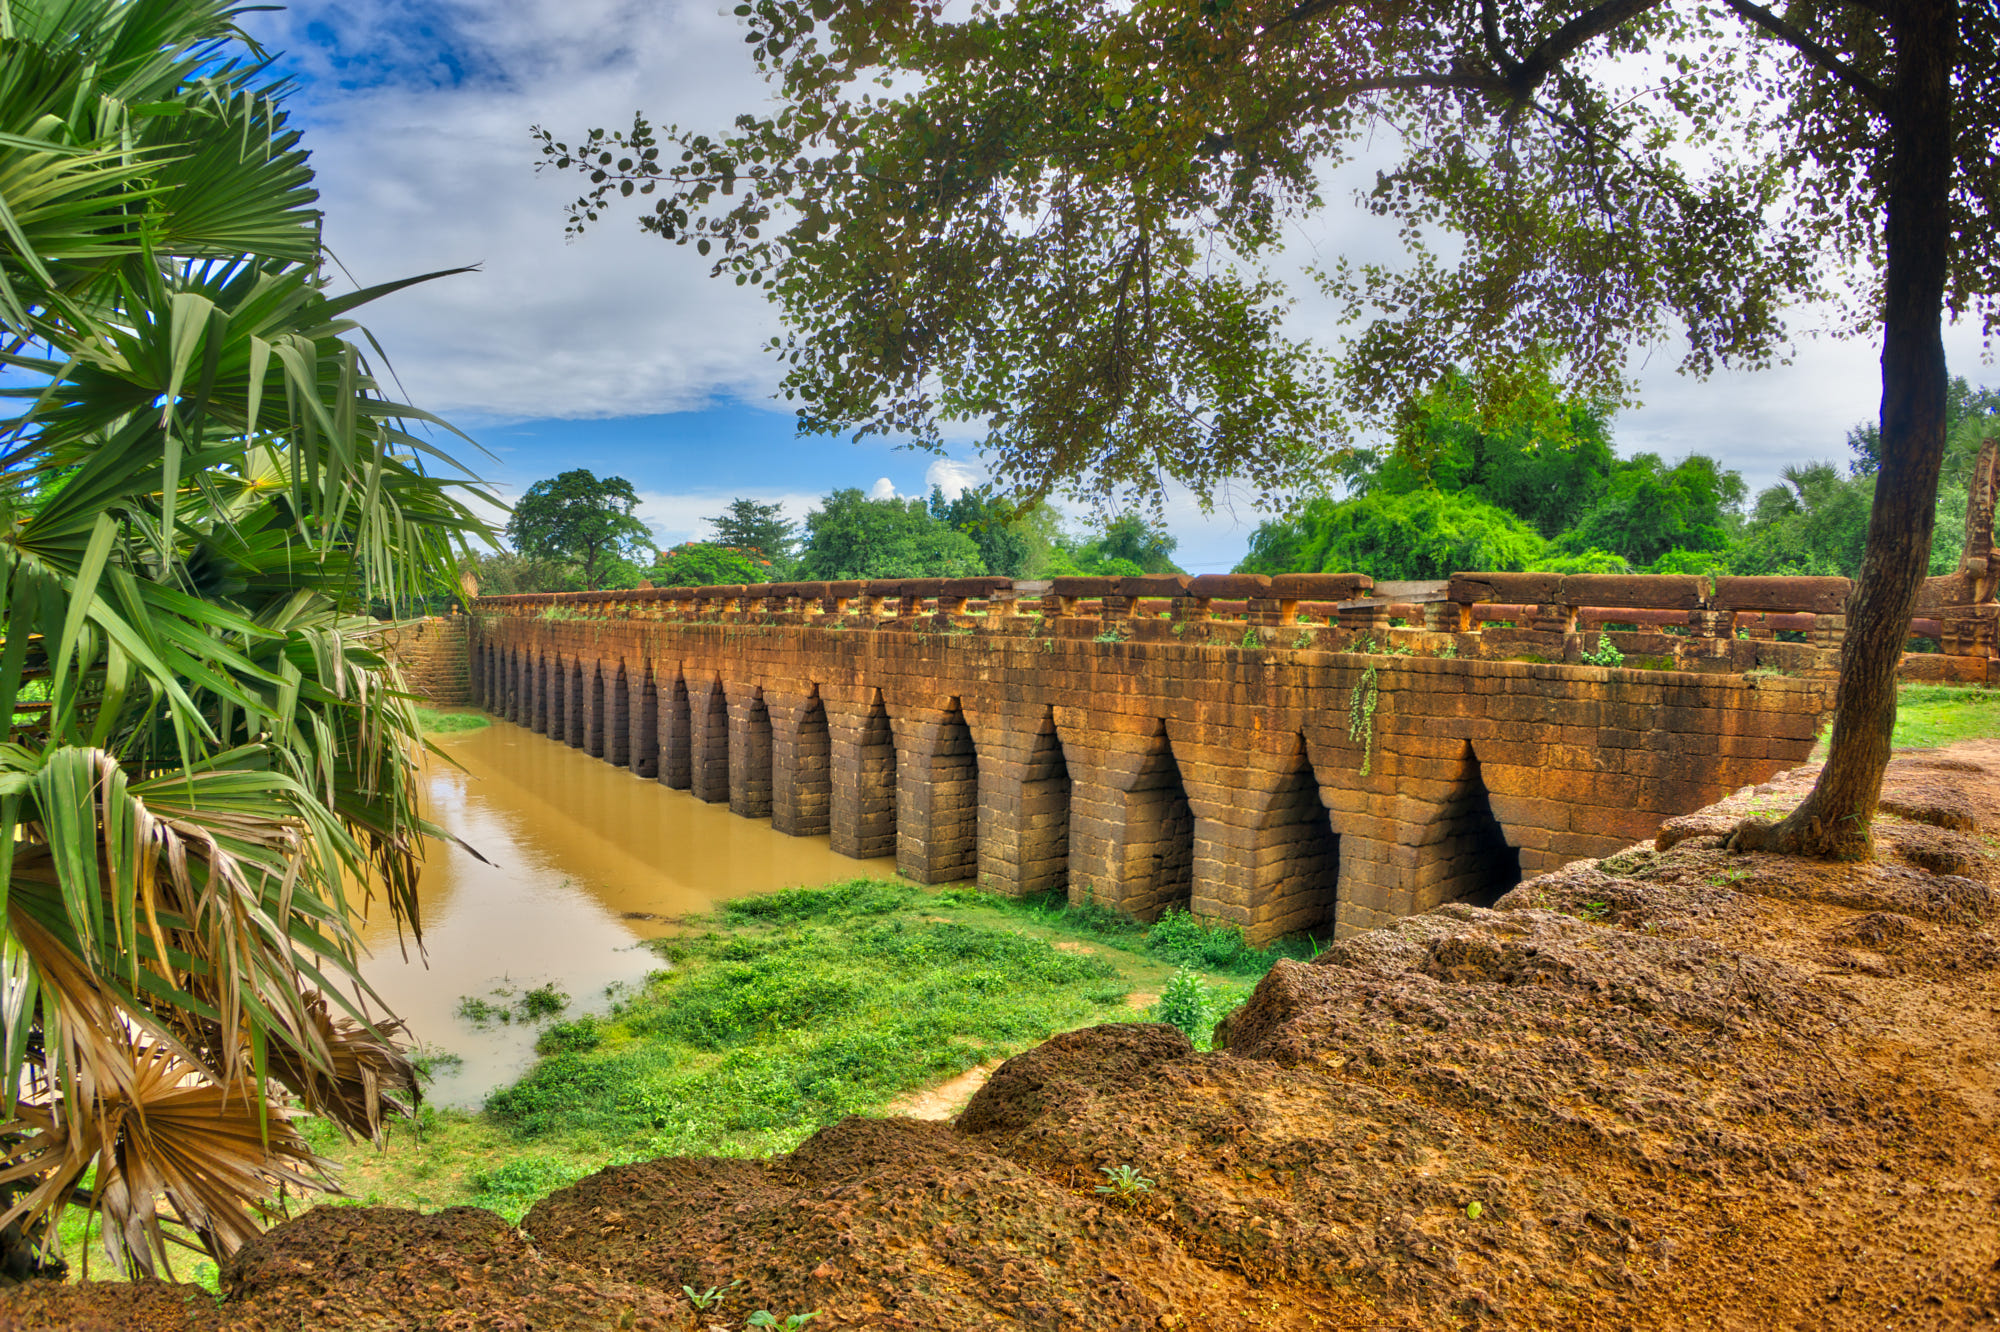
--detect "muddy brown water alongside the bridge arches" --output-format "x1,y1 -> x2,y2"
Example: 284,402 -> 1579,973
362,722 -> 896,1108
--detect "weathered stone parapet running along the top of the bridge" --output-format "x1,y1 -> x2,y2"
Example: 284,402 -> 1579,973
476,572 -> 2000,682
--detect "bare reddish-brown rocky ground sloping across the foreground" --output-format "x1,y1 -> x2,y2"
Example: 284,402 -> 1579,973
0,742 -> 2000,1332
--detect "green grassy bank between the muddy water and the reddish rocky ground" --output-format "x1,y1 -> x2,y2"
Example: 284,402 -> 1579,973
308,880 -> 1312,1220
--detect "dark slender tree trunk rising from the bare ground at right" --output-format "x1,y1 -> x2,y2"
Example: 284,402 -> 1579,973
1730,0 -> 1958,860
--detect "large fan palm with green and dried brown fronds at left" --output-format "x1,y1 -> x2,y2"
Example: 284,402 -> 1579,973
0,0 -> 484,1270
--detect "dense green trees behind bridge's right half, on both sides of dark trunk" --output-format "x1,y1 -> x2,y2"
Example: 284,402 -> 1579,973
1238,374 -> 2000,578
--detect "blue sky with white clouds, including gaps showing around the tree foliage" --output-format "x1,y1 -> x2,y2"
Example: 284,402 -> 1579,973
246,0 -> 2000,572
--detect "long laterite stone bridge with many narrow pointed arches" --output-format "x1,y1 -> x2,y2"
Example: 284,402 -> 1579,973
458,574 -> 1844,942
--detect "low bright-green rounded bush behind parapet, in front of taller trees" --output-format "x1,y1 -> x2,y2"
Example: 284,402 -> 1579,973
1236,490 -> 1546,580
